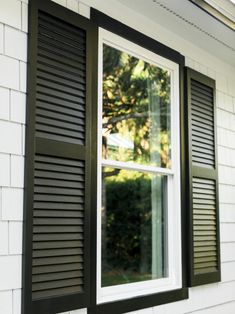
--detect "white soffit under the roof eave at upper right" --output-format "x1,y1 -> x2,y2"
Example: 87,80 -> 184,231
116,0 -> 235,66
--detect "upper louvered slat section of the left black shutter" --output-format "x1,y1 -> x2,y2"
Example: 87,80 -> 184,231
36,13 -> 86,145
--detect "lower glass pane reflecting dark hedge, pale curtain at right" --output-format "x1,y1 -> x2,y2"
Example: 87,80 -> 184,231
101,167 -> 168,287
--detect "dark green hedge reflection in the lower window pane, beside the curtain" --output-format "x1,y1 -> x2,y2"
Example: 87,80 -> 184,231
102,168 -> 152,286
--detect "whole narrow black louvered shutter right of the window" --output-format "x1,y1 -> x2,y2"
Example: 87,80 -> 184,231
186,68 -> 220,286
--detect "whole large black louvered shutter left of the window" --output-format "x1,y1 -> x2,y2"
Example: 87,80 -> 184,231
22,0 -> 97,314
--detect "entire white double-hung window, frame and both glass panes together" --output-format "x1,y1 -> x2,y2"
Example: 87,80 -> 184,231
97,30 -> 181,303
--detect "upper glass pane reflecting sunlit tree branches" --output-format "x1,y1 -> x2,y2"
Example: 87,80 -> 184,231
102,44 -> 171,168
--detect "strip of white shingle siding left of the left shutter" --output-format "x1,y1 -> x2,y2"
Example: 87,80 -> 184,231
0,0 -> 28,314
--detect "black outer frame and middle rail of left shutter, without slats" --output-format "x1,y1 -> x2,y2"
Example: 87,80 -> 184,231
22,0 -> 97,314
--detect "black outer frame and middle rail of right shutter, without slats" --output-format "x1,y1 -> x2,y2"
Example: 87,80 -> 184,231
185,68 -> 221,287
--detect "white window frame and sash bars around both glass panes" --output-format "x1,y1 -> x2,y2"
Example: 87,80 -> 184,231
96,28 -> 182,304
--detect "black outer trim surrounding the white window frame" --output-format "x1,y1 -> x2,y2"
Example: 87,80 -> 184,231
88,8 -> 188,314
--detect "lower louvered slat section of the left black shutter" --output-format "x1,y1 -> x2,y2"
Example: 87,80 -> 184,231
32,154 -> 85,300
